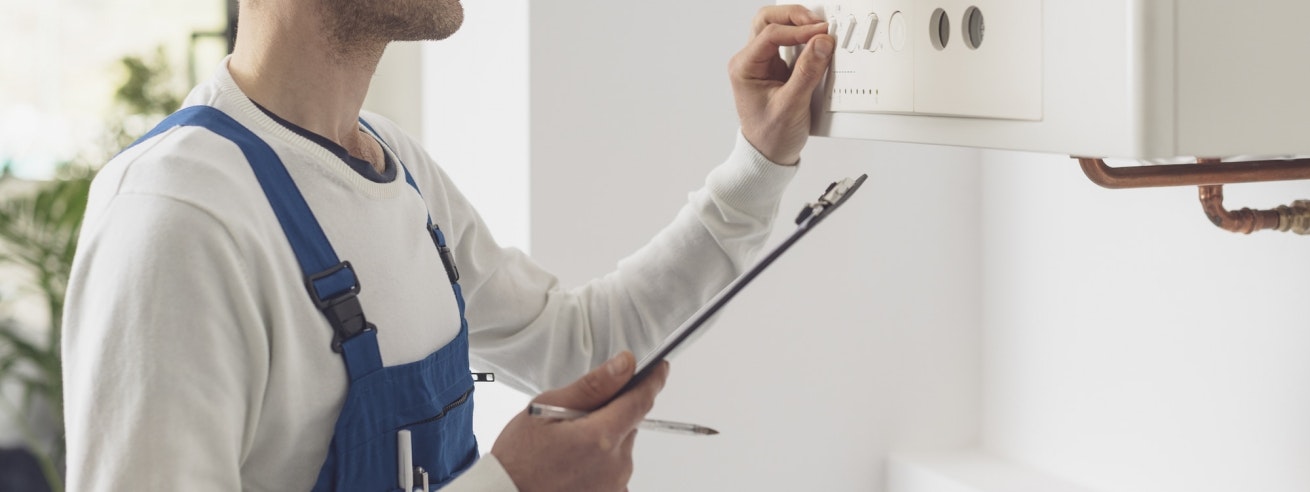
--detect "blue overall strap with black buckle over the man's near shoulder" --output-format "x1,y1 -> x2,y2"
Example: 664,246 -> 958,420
132,106 -> 383,381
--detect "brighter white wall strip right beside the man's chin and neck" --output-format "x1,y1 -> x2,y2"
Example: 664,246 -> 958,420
409,0 -> 529,251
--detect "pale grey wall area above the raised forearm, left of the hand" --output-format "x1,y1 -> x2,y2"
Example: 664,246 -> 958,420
531,0 -> 764,269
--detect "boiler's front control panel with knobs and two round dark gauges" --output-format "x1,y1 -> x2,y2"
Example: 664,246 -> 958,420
808,0 -> 1043,120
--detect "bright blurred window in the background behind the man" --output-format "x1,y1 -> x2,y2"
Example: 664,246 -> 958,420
0,0 -> 227,179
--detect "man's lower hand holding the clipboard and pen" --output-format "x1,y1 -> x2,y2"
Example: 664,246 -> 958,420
491,352 -> 668,492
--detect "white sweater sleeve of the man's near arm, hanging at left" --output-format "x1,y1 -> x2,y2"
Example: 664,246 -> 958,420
62,194 -> 267,491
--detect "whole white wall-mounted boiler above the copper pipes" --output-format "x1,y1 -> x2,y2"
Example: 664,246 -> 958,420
778,0 -> 1310,160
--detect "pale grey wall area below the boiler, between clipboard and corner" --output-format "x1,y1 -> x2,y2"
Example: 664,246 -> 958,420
618,140 -> 981,491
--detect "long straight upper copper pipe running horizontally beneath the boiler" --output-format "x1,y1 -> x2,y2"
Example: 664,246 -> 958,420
1074,157 -> 1310,190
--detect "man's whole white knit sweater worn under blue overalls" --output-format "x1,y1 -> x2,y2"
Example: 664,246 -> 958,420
63,61 -> 795,492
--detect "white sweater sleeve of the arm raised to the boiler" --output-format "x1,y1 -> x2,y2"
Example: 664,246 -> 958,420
451,133 -> 796,394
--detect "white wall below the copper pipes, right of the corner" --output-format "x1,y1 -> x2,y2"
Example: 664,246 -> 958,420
983,152 -> 1310,492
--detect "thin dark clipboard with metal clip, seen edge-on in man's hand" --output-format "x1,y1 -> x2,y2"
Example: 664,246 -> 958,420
605,174 -> 869,404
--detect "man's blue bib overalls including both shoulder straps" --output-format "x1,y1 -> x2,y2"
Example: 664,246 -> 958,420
134,106 -> 478,492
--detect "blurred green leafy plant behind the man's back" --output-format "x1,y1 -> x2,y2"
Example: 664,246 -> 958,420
0,50 -> 181,492
